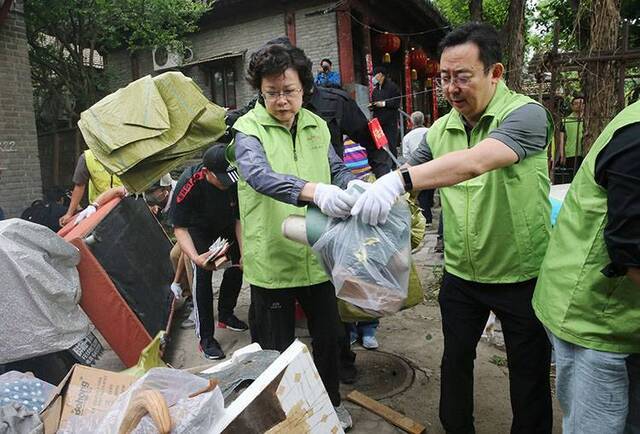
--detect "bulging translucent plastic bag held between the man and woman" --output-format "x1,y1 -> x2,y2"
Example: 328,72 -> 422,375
313,186 -> 411,317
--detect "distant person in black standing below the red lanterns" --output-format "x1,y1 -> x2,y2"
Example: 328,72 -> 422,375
369,66 -> 402,176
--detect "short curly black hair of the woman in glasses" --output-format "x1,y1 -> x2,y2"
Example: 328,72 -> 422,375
247,44 -> 313,101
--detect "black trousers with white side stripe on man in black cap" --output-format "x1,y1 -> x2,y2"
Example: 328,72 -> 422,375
189,229 -> 242,341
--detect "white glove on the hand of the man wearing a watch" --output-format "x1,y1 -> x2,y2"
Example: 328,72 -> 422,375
351,172 -> 404,226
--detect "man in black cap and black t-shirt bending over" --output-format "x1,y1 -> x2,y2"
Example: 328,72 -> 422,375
169,145 -> 248,360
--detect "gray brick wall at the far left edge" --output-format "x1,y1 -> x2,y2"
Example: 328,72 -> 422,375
0,0 -> 42,217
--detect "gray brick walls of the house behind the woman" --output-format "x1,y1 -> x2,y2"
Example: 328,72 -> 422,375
107,3 -> 340,107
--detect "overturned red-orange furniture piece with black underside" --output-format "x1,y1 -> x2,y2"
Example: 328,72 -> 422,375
60,197 -> 174,367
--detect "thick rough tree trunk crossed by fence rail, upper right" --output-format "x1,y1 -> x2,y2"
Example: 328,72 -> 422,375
582,0 -> 620,155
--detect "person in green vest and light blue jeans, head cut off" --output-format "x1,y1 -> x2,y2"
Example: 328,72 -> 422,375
533,102 -> 640,434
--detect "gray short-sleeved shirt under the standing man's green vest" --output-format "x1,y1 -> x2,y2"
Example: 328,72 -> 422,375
407,103 -> 547,166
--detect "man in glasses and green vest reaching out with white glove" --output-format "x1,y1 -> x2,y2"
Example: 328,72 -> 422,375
352,23 -> 553,434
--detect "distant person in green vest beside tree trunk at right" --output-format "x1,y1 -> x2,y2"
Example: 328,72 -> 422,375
558,95 -> 584,171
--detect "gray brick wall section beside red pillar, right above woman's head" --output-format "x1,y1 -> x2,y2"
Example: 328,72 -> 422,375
296,3 -> 340,76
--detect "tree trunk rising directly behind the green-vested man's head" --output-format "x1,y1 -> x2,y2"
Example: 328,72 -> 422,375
504,0 -> 526,92
